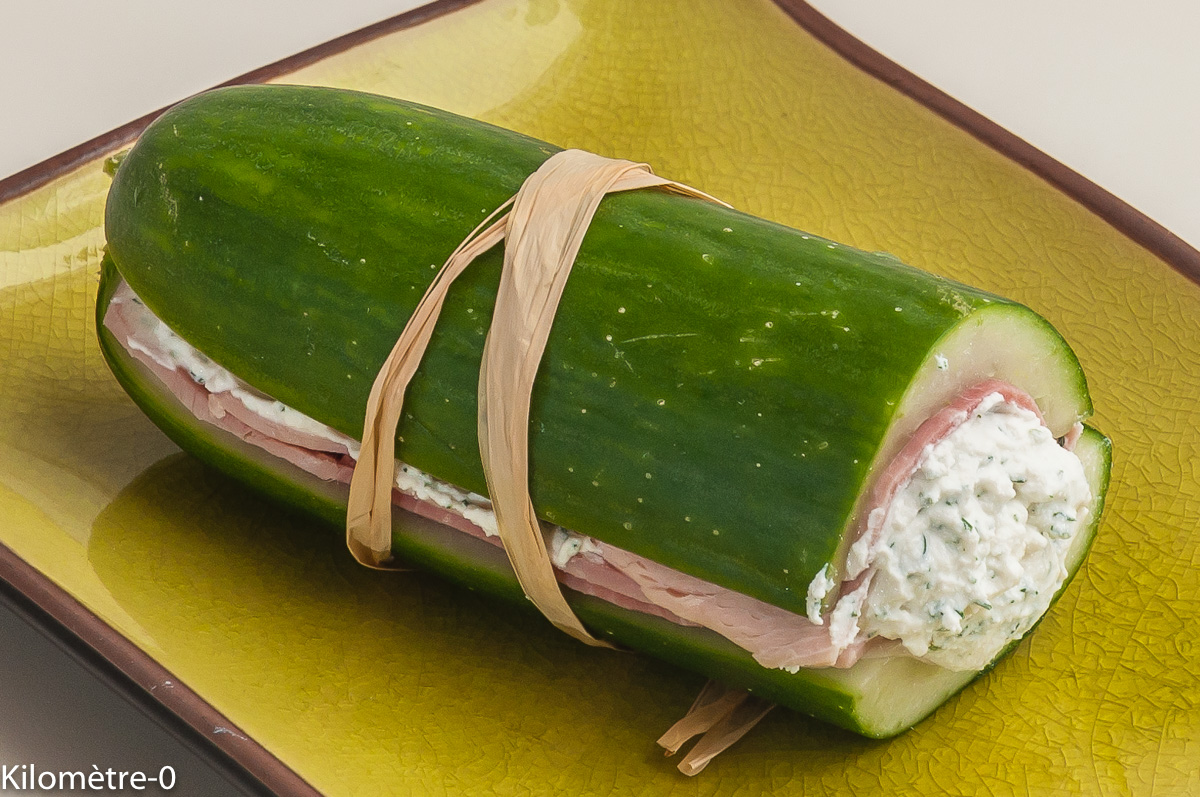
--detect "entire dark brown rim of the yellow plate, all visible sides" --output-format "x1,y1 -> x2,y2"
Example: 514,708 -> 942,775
0,0 -> 1200,797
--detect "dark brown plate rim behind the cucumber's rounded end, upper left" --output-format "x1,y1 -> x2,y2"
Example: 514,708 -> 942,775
0,0 -> 479,203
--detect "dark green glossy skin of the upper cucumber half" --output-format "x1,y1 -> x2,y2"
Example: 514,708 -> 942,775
106,86 -> 1041,613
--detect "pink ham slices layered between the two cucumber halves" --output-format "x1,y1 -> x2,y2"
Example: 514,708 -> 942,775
104,284 -> 1060,667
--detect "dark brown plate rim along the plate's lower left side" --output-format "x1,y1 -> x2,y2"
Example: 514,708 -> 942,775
0,544 -> 320,797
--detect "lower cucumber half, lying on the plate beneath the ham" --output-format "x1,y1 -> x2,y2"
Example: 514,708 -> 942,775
96,258 -> 1111,738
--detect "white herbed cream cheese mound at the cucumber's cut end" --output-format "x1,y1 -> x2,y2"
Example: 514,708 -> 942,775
830,394 -> 1092,670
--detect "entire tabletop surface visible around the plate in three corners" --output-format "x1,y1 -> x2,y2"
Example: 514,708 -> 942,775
0,0 -> 1200,795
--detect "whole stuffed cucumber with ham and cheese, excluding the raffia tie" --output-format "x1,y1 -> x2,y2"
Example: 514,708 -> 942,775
98,86 -> 1108,736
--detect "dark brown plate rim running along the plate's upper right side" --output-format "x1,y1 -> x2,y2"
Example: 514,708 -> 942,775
774,0 -> 1200,283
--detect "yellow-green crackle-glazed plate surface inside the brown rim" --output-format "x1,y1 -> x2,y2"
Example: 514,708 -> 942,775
0,0 -> 1200,797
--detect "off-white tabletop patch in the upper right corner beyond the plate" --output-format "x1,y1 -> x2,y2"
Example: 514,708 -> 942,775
809,0 -> 1200,247
